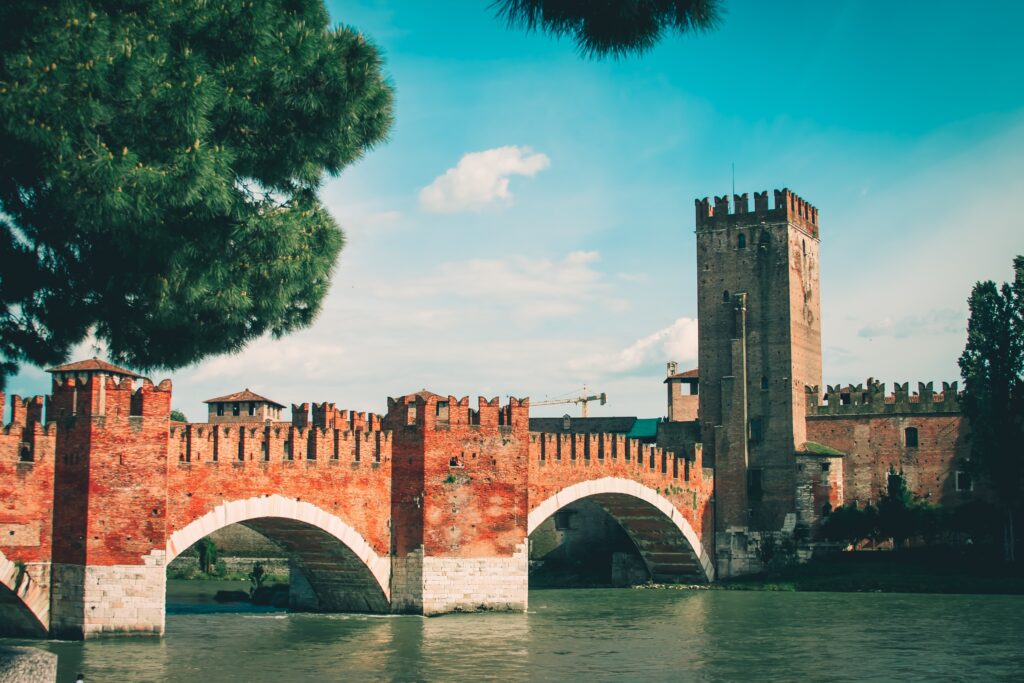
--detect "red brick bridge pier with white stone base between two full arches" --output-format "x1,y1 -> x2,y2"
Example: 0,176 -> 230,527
384,392 -> 529,613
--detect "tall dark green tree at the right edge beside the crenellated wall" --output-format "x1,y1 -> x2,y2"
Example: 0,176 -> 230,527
959,256 -> 1024,560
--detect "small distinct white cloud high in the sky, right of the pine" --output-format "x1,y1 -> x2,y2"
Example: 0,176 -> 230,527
420,145 -> 551,213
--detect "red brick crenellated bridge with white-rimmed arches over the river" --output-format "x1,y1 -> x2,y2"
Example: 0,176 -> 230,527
0,367 -> 714,638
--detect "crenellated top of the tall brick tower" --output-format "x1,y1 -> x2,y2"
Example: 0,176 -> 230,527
694,188 -> 818,238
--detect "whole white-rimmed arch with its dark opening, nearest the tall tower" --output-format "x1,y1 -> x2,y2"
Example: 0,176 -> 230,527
528,477 -> 713,586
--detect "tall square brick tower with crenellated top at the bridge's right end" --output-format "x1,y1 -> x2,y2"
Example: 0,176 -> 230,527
696,189 -> 821,575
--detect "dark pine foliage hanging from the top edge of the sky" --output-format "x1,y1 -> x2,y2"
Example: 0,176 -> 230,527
492,0 -> 720,57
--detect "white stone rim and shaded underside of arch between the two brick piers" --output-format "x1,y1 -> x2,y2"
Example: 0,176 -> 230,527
167,495 -> 391,612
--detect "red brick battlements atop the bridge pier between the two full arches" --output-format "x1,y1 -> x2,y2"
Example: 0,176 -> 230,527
384,390 -> 529,429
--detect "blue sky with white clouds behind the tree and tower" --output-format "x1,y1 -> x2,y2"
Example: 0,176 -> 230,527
4,0 -> 1024,419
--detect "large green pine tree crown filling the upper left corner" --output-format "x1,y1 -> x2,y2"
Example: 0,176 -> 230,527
0,0 -> 392,388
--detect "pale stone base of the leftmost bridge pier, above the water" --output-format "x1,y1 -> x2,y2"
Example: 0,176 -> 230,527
50,550 -> 167,639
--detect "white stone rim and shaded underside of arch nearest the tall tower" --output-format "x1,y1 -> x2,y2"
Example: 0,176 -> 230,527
526,477 -> 715,582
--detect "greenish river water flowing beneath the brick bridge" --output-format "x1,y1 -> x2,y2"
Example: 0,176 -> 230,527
3,582 -> 1024,683
